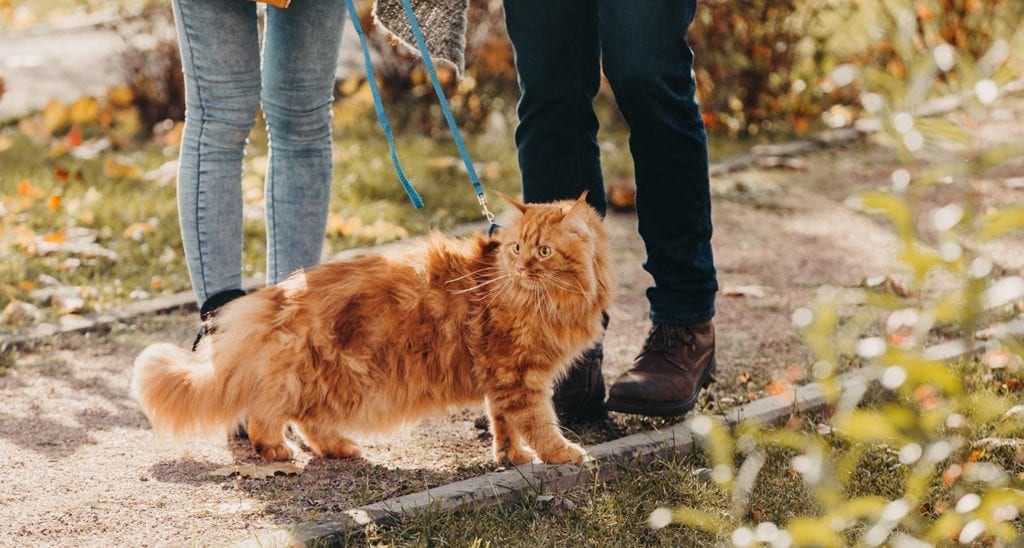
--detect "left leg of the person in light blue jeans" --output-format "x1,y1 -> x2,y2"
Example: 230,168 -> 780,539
173,0 -> 260,304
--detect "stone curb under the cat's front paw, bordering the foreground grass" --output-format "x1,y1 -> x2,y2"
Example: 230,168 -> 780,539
234,369 -> 876,548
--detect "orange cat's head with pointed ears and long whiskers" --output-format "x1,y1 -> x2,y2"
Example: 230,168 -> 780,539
497,192 -> 610,295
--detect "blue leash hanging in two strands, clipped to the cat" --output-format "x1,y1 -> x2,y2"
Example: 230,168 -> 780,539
345,0 -> 499,236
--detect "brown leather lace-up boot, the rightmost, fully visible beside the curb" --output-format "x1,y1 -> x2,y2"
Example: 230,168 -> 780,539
605,321 -> 715,417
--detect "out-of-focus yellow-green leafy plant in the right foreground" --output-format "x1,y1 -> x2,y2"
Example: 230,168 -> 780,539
651,2 -> 1024,547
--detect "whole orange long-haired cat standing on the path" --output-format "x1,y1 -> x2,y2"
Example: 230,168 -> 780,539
132,194 -> 612,464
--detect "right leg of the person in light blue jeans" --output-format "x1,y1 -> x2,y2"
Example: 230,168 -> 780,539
262,0 -> 344,284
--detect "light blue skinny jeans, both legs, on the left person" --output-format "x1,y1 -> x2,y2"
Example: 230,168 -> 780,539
173,0 -> 344,304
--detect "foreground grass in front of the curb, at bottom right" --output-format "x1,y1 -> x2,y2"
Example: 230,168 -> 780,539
329,362 -> 1024,546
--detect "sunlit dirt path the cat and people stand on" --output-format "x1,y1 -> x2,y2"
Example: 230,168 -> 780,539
0,101 -> 1024,546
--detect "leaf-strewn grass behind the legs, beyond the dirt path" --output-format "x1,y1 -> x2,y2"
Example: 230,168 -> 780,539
0,82 -> 765,331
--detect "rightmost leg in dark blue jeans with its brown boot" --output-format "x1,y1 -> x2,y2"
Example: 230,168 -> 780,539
599,0 -> 718,415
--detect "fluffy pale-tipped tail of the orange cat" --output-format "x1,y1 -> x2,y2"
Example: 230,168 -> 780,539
131,343 -> 245,434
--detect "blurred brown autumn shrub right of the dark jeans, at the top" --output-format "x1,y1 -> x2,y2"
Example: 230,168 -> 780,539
688,0 -> 855,134
